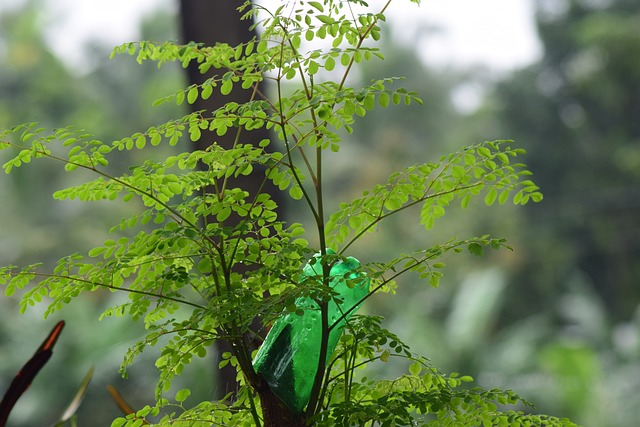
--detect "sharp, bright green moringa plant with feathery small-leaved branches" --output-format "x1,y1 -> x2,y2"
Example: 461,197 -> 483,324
0,0 -> 573,427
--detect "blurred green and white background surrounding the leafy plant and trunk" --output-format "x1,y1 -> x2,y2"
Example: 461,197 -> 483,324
0,0 -> 640,427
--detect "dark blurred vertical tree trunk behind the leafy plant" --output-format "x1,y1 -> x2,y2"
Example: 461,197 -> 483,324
180,0 -> 280,402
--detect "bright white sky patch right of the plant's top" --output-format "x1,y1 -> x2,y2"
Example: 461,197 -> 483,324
390,0 -> 542,72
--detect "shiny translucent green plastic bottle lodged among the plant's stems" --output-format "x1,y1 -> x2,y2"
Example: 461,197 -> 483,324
253,249 -> 369,414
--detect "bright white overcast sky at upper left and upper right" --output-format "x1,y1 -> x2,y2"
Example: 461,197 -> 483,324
13,0 -> 540,72
